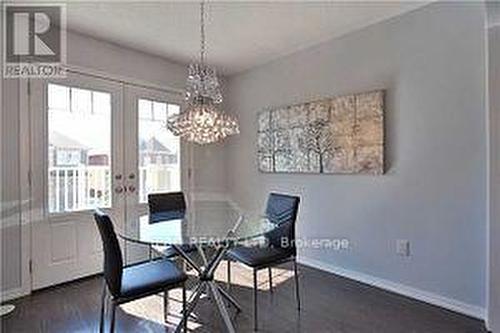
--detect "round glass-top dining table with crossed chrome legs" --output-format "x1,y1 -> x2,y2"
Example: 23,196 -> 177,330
117,203 -> 276,332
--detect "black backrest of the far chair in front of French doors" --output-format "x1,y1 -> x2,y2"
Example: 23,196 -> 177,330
148,192 -> 186,222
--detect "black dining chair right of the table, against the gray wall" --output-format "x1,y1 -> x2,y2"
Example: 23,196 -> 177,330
227,193 -> 300,330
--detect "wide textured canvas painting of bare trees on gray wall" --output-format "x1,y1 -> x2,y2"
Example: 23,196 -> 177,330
257,90 -> 384,175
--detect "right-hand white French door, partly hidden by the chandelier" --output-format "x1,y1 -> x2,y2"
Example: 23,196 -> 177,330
124,85 -> 191,263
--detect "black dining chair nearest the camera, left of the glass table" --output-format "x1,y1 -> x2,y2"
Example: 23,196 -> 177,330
94,210 -> 187,333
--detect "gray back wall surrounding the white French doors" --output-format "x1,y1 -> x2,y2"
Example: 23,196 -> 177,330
0,33 -> 226,292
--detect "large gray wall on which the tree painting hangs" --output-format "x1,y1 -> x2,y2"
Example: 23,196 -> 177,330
227,3 -> 486,307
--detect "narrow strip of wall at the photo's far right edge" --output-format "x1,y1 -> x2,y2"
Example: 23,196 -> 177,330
488,25 -> 500,332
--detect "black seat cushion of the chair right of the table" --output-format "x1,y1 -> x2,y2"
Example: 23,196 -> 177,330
227,246 -> 295,267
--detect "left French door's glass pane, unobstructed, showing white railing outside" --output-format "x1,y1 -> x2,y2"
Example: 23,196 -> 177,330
47,84 -> 111,213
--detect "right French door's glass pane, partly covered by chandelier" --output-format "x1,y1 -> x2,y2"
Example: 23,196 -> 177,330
138,99 -> 181,203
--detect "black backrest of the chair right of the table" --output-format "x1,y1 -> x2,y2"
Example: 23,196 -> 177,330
266,193 -> 300,250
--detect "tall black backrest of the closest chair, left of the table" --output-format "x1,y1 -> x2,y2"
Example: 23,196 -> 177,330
94,210 -> 123,296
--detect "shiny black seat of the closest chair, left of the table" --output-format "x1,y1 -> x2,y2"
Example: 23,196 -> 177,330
120,260 -> 187,298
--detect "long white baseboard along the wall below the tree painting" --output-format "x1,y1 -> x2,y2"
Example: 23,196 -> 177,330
298,256 -> 486,320
